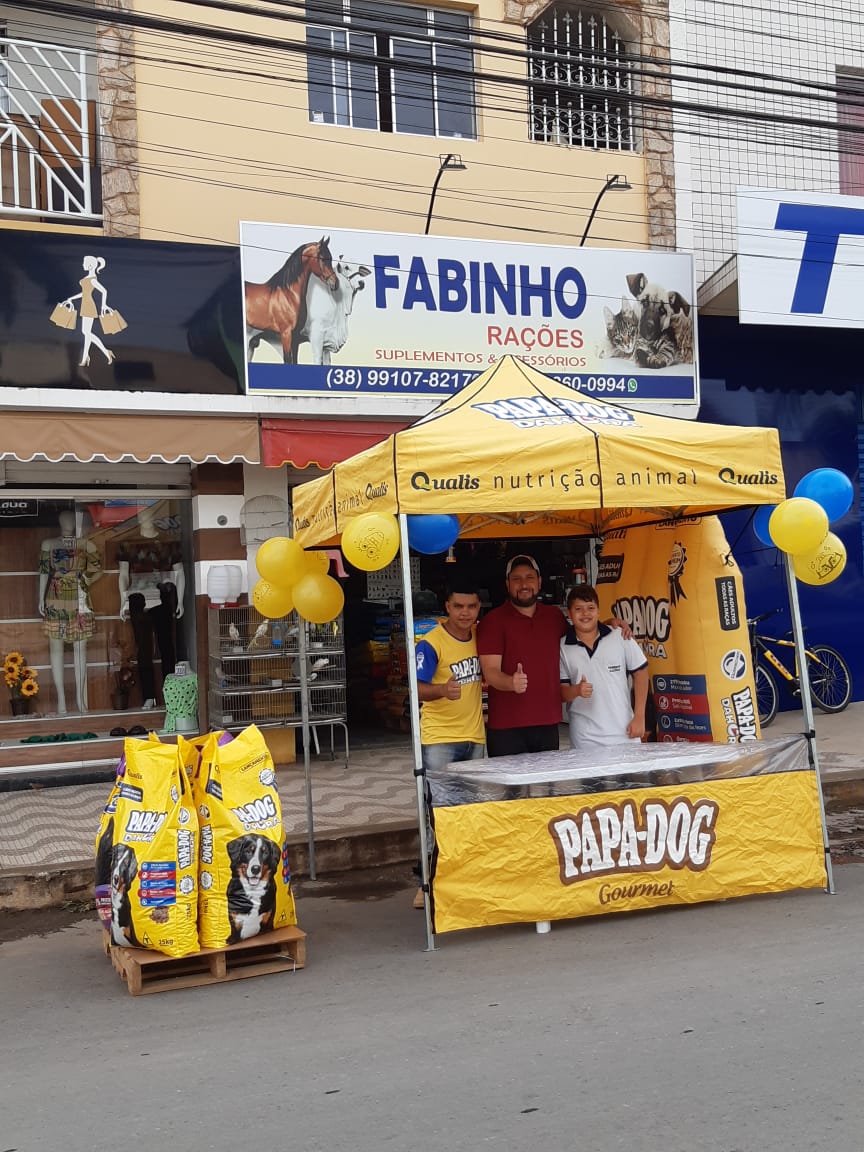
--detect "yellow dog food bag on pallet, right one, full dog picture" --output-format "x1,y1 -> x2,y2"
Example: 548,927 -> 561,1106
196,725 -> 297,948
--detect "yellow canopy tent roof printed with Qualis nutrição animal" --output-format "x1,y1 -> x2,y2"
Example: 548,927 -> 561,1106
294,356 -> 786,547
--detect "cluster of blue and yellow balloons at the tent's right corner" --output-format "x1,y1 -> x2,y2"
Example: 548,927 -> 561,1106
753,468 -> 852,586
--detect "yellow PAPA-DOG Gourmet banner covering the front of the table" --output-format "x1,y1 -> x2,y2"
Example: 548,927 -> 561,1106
432,771 -> 827,932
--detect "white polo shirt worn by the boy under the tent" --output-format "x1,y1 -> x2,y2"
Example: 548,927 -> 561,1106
561,624 -> 647,748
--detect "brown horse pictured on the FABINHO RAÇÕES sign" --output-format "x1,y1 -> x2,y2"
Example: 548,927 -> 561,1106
243,236 -> 339,364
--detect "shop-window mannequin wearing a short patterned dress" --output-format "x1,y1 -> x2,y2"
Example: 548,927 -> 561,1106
39,509 -> 103,715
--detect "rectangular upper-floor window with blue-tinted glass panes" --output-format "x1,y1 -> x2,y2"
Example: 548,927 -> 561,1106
306,0 -> 476,138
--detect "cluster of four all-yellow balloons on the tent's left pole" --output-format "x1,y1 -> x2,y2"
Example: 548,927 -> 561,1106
252,536 -> 344,624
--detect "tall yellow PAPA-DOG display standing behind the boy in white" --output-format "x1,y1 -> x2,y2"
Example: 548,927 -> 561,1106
598,516 -> 759,743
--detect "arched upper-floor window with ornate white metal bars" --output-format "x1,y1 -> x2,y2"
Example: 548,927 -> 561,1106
528,3 -> 635,152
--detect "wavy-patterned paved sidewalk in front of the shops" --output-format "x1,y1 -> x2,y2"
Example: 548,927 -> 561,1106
0,703 -> 864,874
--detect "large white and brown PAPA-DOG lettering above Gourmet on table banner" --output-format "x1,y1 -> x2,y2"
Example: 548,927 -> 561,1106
548,796 -> 718,885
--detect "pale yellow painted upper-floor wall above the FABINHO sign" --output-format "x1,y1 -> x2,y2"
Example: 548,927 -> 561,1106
136,0 -> 647,248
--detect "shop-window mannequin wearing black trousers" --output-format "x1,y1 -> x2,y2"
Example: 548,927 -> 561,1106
118,507 -> 185,710
